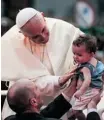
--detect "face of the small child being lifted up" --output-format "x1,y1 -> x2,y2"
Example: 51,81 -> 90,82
72,45 -> 93,64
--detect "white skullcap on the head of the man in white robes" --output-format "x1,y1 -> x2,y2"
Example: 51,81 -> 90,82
16,8 -> 39,28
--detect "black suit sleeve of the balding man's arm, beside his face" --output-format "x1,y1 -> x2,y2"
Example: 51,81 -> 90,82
41,94 -> 72,119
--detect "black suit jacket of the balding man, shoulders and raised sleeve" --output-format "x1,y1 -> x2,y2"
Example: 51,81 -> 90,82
5,95 -> 72,120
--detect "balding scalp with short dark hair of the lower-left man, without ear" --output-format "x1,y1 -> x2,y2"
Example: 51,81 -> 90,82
7,80 -> 42,113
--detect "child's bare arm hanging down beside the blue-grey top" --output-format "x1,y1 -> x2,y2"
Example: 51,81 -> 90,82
74,67 -> 91,99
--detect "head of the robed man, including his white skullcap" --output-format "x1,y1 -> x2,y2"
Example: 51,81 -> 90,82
16,8 -> 49,44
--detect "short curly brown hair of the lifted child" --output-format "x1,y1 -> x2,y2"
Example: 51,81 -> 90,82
73,35 -> 97,53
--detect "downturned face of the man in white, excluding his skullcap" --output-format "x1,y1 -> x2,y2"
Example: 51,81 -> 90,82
21,16 -> 49,44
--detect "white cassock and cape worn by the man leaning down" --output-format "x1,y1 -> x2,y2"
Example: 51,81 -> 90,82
1,18 -> 83,119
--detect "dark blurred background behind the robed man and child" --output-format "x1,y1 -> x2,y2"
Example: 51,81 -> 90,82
1,0 -> 104,113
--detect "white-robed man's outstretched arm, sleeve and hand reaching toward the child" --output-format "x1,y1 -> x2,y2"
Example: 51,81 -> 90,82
34,71 -> 74,96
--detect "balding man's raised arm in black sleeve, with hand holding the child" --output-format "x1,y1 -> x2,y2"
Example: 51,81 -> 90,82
41,81 -> 76,118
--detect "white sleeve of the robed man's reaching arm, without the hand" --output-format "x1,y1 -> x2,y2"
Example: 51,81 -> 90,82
34,75 -> 60,96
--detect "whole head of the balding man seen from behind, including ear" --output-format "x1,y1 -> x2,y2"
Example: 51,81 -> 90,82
7,80 -> 43,113
